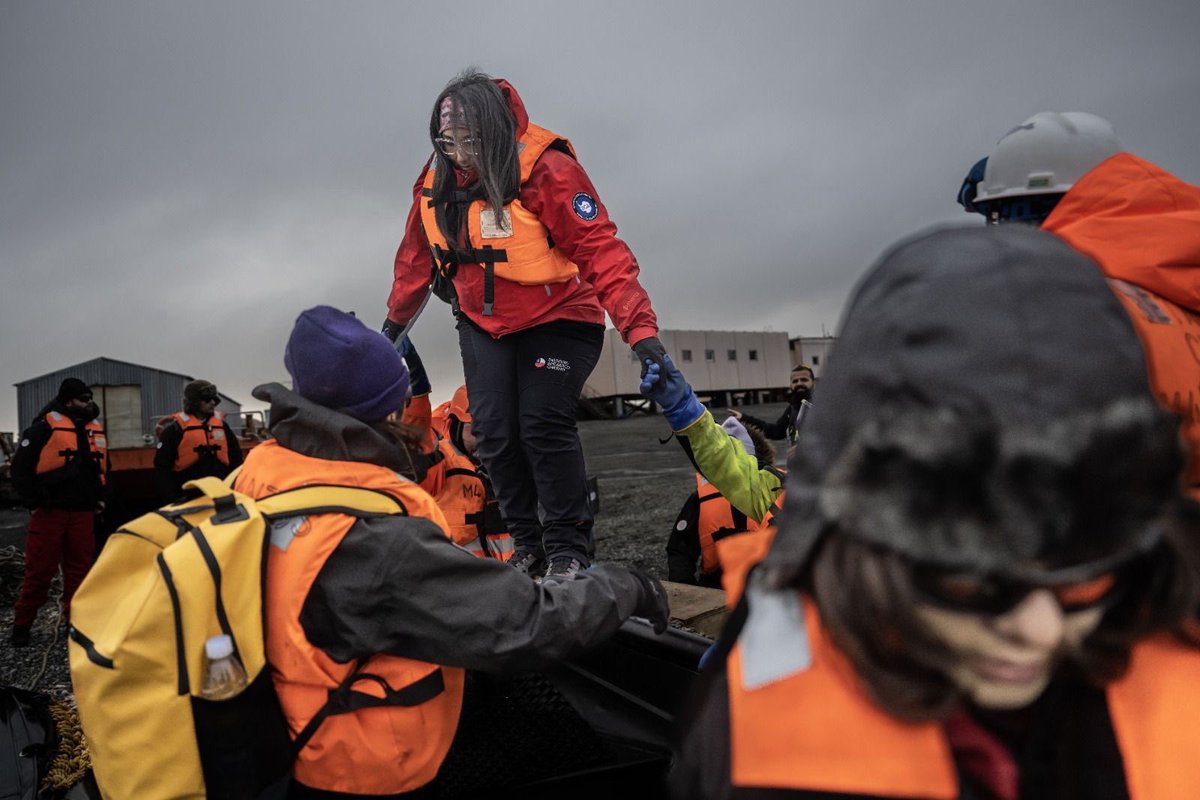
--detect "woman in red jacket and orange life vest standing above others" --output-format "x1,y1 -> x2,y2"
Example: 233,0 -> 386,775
384,72 -> 665,581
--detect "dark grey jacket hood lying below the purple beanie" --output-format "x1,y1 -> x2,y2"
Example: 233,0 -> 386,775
251,383 -> 413,475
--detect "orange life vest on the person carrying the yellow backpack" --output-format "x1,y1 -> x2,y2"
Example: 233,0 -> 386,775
235,441 -> 463,795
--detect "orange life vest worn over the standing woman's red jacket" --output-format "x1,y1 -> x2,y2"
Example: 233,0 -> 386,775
421,122 -> 580,314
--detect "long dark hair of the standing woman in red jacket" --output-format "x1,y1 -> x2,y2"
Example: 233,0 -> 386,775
430,67 -> 521,246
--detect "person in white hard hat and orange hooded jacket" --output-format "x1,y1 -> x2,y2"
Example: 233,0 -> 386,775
959,112 -> 1200,499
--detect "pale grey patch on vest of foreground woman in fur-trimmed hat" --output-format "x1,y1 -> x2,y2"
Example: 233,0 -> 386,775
738,585 -> 812,690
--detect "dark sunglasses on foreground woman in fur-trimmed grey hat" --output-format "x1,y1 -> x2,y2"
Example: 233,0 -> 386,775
913,567 -> 1121,614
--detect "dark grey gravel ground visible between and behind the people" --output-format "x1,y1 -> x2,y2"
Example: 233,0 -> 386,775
0,404 -> 784,699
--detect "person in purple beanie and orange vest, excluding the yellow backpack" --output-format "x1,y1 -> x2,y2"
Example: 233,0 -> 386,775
234,306 -> 667,798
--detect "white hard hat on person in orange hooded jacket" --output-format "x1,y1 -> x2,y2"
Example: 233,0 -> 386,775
974,112 -> 1123,204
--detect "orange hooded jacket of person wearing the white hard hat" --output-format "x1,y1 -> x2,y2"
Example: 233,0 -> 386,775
1042,152 -> 1200,498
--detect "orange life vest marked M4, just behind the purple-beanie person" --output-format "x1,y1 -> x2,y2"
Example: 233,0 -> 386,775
421,431 -> 515,561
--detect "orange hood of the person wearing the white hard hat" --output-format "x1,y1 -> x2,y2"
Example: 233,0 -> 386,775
1042,152 -> 1200,311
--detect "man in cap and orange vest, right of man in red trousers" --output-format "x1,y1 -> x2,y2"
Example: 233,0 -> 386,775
154,380 -> 241,503
